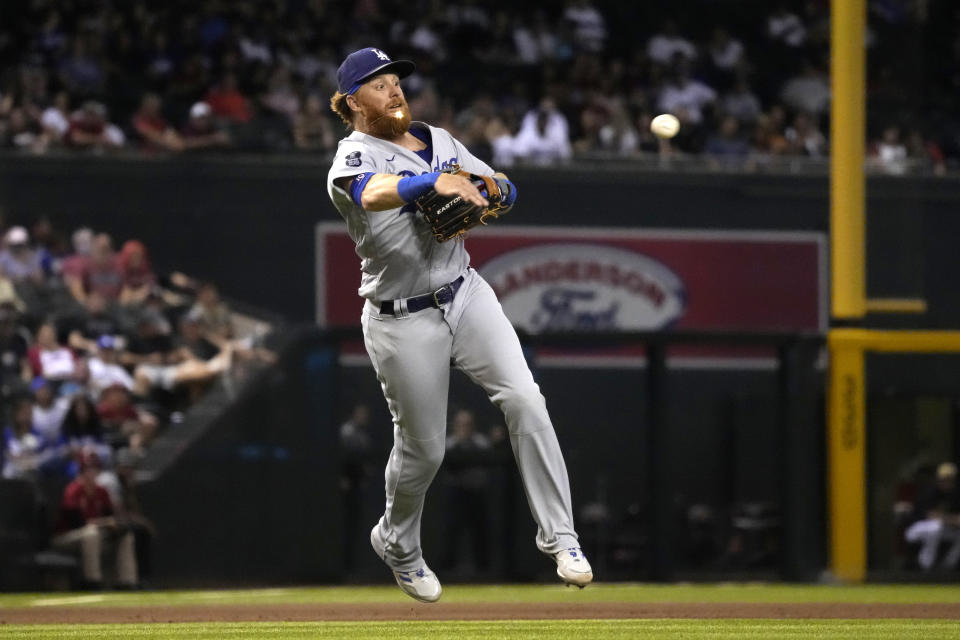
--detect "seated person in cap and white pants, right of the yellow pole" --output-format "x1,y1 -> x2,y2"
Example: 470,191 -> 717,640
904,462 -> 960,571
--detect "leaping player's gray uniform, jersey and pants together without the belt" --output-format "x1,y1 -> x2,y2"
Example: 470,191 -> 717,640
327,123 -> 579,572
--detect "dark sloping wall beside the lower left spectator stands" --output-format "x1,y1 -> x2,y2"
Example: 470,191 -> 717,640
140,331 -> 342,587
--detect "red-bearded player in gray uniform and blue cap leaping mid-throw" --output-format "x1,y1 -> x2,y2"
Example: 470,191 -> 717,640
327,48 -> 593,602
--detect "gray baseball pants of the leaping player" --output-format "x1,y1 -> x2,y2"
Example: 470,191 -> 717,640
362,269 -> 579,571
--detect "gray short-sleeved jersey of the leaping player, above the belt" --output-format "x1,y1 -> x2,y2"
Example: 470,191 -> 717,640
327,122 -> 494,300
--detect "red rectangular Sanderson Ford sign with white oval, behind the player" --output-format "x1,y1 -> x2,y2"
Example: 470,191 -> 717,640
317,223 -> 827,331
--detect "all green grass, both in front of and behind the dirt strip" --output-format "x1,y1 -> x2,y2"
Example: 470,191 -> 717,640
0,583 -> 960,640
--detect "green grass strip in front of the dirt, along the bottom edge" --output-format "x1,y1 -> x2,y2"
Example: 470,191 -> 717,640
0,620 -> 960,640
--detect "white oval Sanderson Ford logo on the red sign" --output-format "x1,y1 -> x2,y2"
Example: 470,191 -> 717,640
480,243 -> 686,333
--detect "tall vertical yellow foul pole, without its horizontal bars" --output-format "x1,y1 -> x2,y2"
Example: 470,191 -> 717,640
827,0 -> 867,581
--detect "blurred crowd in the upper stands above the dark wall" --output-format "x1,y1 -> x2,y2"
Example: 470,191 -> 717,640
0,0 -> 960,173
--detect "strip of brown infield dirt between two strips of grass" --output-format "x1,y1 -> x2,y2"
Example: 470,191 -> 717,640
0,602 -> 960,624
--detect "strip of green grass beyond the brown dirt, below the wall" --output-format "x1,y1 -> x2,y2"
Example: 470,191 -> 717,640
0,583 -> 960,607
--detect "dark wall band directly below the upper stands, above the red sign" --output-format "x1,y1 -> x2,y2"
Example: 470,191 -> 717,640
0,156 -> 960,326
